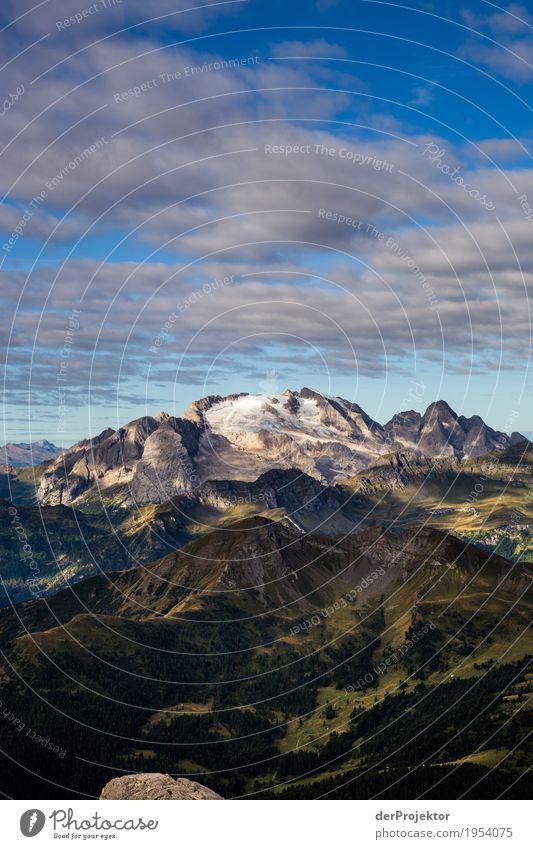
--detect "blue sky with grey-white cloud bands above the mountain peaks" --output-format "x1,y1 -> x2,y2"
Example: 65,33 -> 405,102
0,0 -> 533,446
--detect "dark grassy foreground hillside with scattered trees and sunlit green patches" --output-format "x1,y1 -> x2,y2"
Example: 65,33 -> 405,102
0,518 -> 532,798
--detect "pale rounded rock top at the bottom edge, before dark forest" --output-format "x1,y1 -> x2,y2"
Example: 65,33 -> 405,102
100,772 -> 222,800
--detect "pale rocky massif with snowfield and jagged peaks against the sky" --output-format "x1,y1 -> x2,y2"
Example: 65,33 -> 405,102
38,389 -> 524,505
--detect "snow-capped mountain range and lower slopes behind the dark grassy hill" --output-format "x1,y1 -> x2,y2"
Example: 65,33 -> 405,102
0,389 -> 533,606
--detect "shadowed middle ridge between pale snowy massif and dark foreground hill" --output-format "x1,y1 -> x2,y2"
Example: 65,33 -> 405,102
0,469 -> 368,607
